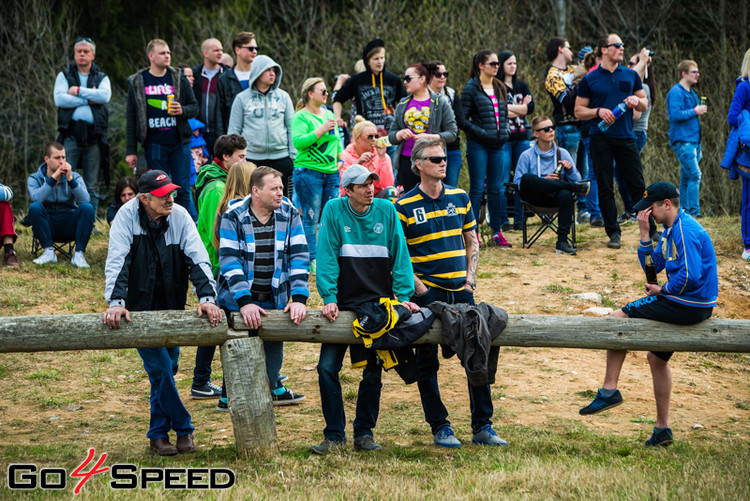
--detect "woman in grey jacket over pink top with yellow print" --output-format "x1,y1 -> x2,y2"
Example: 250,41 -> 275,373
388,63 -> 458,192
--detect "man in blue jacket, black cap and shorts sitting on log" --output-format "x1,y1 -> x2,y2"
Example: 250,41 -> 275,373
580,181 -> 719,446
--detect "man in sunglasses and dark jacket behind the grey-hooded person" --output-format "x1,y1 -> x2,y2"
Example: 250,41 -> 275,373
216,31 -> 260,135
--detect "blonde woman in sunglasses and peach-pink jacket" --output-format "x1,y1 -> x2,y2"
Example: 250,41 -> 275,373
339,115 -> 397,198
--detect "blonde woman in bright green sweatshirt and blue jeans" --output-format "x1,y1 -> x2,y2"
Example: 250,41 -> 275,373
292,77 -> 344,273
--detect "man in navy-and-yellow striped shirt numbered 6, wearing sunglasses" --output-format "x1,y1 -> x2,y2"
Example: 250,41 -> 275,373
396,138 -> 508,448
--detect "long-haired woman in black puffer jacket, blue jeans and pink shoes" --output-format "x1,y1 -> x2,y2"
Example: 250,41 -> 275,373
461,50 -> 511,247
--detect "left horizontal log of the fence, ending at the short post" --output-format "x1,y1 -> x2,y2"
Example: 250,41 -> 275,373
0,310 -> 241,353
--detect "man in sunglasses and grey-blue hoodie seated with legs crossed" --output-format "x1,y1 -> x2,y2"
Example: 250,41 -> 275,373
513,116 -> 590,254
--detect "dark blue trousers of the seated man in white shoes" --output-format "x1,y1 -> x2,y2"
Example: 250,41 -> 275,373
29,202 -> 94,252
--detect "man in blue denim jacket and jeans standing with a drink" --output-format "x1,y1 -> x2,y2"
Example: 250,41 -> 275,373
667,60 -> 706,217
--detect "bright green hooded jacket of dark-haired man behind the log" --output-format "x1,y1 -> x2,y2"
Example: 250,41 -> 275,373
195,159 -> 227,278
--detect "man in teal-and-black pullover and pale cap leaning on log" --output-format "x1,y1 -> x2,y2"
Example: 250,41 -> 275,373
310,164 -> 419,455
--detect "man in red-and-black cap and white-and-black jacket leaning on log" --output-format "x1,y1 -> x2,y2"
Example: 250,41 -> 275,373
103,170 -> 221,456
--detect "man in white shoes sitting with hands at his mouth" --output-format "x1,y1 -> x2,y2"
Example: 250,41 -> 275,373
26,142 -> 95,268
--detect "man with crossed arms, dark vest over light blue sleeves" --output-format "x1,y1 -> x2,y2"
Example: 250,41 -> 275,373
54,38 -> 112,214
